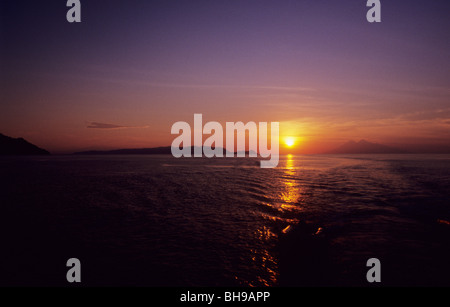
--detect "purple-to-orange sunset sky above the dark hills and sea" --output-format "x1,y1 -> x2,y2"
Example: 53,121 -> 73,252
0,0 -> 450,153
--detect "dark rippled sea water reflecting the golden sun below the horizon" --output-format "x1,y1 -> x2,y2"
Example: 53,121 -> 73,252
0,155 -> 450,286
